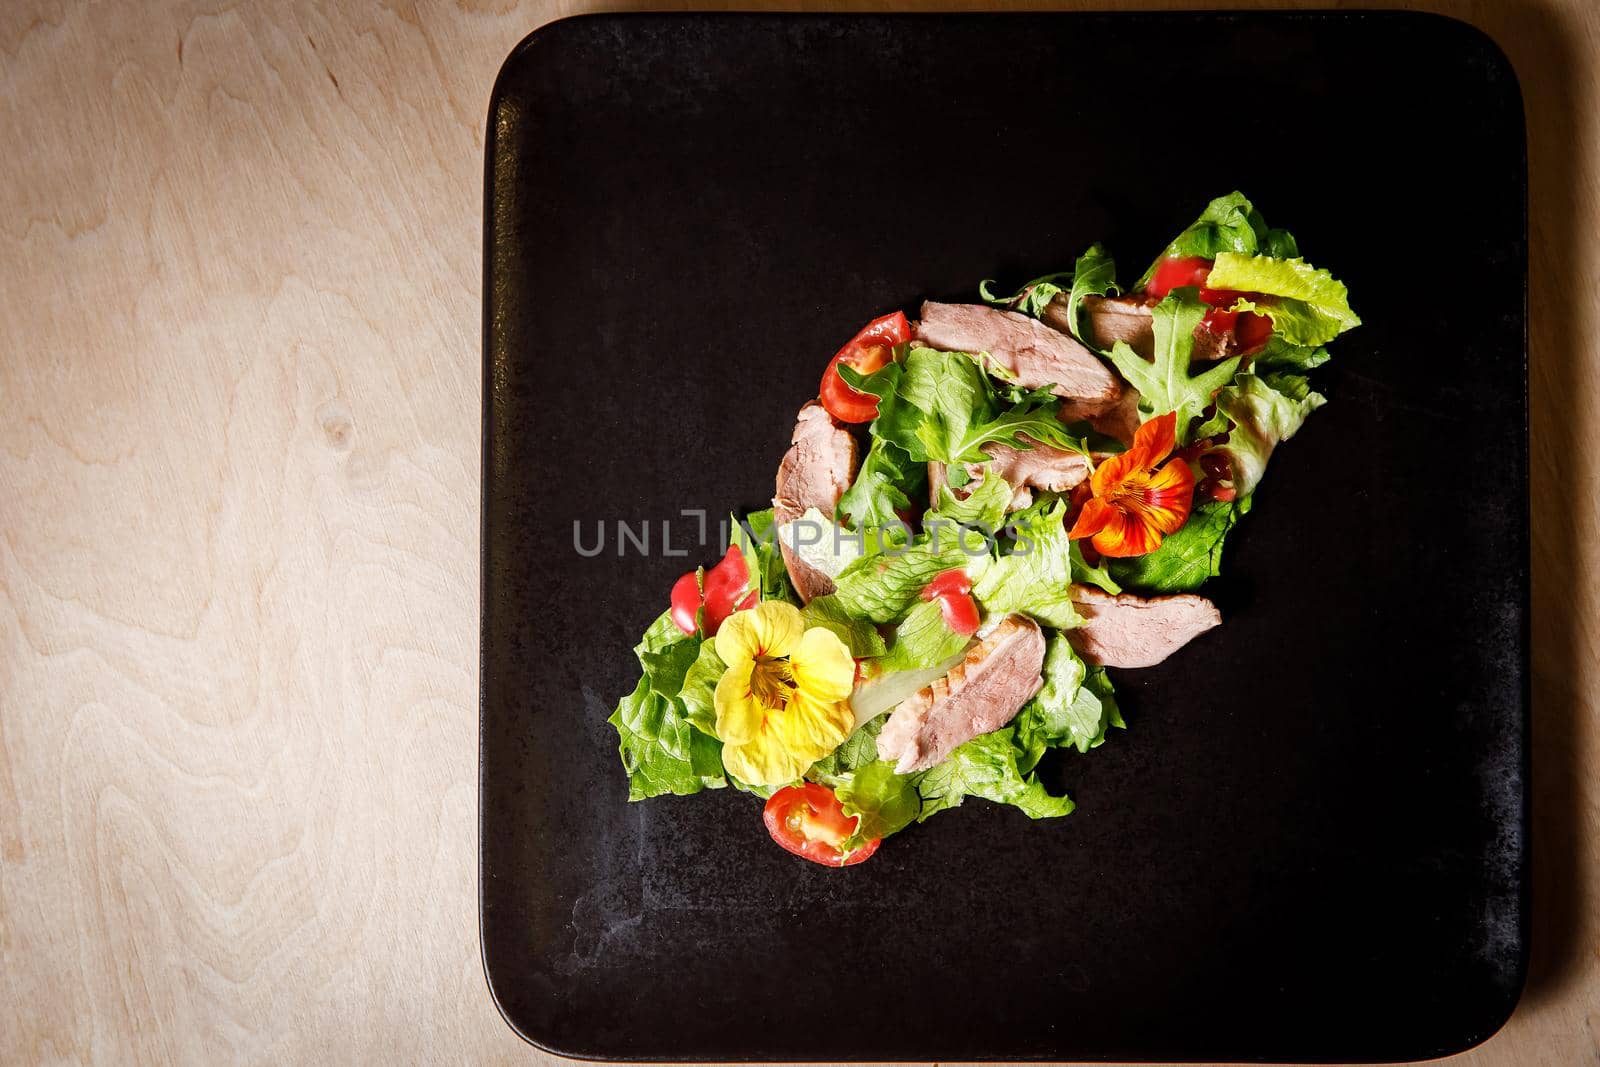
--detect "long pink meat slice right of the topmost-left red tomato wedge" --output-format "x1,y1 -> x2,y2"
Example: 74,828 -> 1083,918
914,301 -> 1120,405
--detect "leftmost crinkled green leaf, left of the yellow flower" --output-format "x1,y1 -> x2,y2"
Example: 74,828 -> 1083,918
606,677 -> 726,800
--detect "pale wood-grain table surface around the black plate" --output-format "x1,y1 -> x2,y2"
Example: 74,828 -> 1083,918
0,0 -> 1600,1064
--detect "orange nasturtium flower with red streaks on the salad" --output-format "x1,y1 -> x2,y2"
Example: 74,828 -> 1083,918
1067,411 -> 1195,555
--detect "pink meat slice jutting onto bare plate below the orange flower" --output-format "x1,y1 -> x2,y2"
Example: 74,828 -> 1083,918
1066,585 -> 1222,667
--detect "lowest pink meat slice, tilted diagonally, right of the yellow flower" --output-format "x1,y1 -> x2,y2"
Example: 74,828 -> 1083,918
878,614 -> 1045,774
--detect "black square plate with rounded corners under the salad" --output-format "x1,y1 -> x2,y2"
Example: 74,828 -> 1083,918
482,13 -> 1528,1061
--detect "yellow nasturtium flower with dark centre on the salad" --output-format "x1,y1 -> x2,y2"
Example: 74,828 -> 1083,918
717,600 -> 856,785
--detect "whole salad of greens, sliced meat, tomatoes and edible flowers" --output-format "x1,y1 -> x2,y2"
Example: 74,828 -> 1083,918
608,192 -> 1360,867
